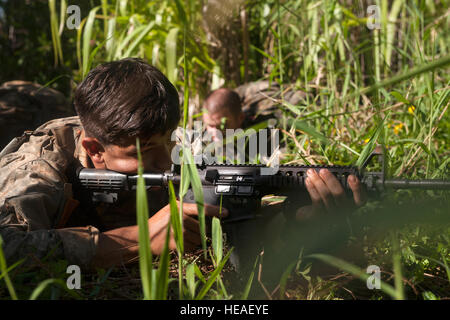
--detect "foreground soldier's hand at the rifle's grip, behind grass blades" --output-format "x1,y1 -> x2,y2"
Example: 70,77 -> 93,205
148,201 -> 228,255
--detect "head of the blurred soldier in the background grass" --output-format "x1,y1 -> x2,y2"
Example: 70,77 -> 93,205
203,88 -> 245,140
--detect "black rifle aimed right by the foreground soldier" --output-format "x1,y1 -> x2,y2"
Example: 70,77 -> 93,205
77,152 -> 450,266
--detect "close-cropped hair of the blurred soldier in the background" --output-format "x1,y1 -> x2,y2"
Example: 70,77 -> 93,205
204,88 -> 242,117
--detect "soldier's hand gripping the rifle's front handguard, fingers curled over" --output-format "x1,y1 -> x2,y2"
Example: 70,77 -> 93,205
296,169 -> 367,221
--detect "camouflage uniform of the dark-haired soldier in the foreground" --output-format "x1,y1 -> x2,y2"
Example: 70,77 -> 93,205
0,117 -> 167,268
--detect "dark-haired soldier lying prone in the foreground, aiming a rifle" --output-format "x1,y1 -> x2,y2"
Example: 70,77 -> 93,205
0,58 -> 365,268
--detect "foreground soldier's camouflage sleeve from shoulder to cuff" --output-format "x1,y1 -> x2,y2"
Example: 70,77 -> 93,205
0,125 -> 98,267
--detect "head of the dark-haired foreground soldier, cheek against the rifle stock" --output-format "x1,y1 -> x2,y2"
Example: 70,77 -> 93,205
74,58 -> 180,173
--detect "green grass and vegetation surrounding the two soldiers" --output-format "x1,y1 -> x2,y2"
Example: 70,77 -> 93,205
0,0 -> 450,299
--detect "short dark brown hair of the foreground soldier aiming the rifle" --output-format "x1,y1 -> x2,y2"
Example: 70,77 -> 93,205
74,58 -> 180,146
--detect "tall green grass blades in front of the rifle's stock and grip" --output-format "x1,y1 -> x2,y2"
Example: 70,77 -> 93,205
136,139 -> 231,300
